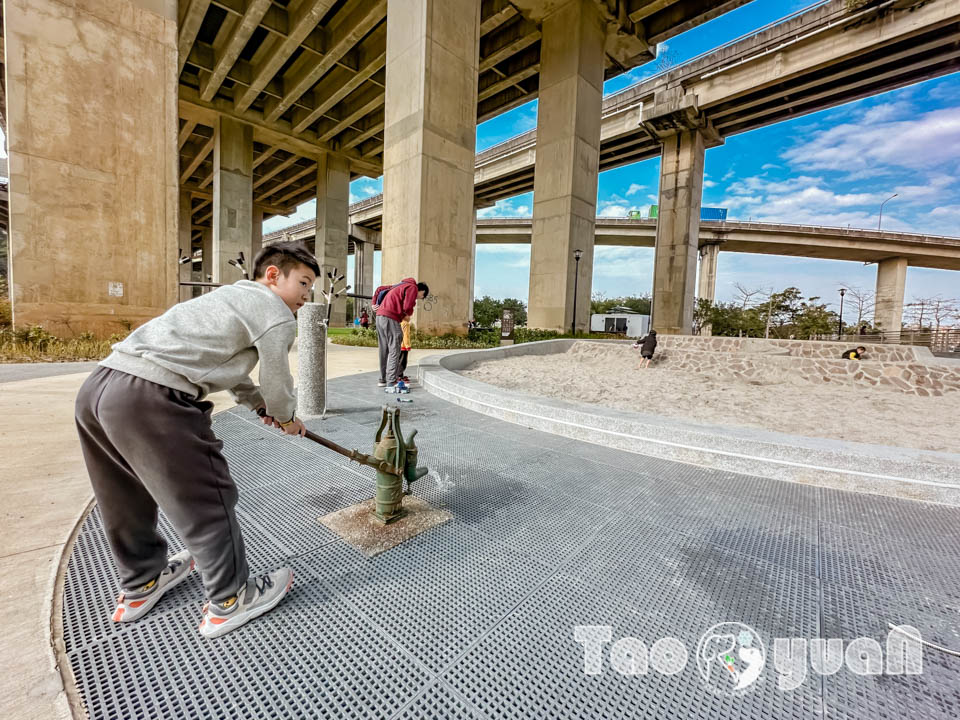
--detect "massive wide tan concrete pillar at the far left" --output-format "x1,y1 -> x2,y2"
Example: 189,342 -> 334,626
3,0 -> 179,337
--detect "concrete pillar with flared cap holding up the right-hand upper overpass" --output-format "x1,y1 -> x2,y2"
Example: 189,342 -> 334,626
641,88 -> 722,335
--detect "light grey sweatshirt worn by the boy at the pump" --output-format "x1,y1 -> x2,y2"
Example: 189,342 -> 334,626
100,280 -> 297,422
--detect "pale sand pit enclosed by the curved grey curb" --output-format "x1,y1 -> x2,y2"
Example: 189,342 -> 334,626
462,343 -> 960,453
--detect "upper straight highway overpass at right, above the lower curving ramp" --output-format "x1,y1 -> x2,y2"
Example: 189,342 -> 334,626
475,0 -> 960,205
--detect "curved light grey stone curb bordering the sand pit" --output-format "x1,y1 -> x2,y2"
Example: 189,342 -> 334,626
419,339 -> 960,506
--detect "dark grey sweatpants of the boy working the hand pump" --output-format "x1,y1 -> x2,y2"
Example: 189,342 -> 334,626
76,367 -> 249,601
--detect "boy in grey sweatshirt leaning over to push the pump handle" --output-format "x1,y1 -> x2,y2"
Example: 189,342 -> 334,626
76,243 -> 320,637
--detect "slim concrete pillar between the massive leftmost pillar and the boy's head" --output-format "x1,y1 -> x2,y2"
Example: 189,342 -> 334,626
211,115 -> 253,285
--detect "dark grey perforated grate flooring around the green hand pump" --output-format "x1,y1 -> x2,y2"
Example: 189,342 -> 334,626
63,374 -> 960,720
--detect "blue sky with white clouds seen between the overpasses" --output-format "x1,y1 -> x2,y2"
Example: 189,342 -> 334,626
265,0 -> 960,316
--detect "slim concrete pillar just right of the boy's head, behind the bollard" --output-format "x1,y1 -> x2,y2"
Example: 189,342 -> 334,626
314,153 -> 353,327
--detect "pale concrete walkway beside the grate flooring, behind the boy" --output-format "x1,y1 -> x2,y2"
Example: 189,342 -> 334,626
0,345 -> 458,720
